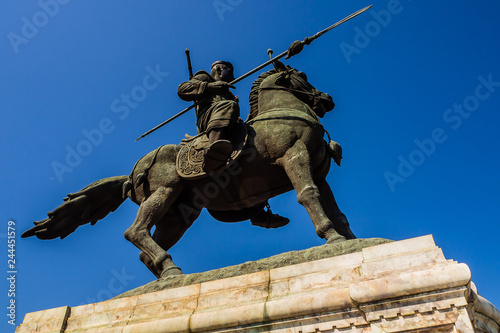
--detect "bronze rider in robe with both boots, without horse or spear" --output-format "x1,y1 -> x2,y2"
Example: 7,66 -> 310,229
177,60 -> 290,228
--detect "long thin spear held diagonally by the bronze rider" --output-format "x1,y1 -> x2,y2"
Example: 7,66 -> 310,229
135,5 -> 373,141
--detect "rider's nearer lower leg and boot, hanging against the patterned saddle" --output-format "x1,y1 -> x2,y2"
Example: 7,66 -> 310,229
203,128 -> 233,173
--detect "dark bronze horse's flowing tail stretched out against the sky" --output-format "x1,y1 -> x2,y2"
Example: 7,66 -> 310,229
21,176 -> 129,239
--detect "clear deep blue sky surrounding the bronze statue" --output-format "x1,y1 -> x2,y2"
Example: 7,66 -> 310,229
0,0 -> 500,332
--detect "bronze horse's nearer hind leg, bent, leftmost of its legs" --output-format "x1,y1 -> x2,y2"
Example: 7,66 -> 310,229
125,187 -> 182,275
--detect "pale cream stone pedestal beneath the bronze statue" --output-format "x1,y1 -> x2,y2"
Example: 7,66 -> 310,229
16,236 -> 500,333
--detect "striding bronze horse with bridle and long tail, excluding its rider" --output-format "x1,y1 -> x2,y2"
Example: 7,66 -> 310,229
22,66 -> 355,278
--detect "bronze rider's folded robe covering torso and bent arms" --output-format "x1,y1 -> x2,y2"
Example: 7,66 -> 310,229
177,71 -> 240,133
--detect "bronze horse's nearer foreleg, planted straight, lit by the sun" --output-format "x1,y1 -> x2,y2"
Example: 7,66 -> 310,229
276,140 -> 346,243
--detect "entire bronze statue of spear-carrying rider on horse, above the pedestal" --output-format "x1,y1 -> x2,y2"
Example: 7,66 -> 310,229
22,6 -> 371,278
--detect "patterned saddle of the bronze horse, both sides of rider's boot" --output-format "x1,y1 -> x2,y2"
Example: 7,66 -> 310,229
175,119 -> 248,180
